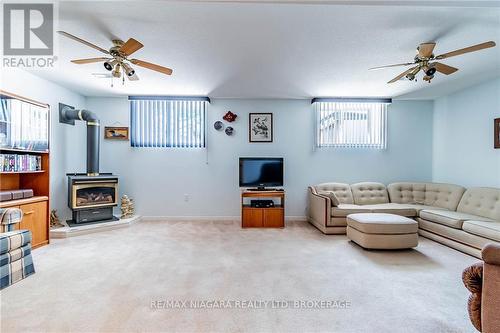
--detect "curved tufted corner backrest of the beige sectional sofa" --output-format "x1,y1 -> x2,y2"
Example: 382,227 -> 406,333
387,183 -> 465,210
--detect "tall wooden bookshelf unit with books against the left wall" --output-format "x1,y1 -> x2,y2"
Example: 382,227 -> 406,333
0,90 -> 50,248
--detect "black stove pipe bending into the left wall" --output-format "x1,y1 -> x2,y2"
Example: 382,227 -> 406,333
63,107 -> 100,176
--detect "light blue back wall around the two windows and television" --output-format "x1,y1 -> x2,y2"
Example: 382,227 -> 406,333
86,98 -> 433,216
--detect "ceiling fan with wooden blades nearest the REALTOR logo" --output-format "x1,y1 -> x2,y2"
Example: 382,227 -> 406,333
58,31 -> 172,81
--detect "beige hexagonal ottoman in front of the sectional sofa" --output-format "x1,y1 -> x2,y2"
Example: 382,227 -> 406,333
347,213 -> 418,250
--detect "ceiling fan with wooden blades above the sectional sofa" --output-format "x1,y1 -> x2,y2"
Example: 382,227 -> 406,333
370,41 -> 496,83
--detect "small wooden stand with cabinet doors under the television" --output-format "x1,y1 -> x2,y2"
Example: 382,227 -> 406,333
241,189 -> 285,228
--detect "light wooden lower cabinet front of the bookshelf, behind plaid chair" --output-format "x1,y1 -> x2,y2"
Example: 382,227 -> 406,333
19,201 -> 49,247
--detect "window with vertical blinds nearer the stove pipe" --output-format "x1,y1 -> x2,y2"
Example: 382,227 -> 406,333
129,96 -> 210,148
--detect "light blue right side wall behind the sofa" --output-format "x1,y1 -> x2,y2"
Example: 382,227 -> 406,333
433,78 -> 500,187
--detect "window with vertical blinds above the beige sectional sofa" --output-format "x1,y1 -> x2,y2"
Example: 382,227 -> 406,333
312,98 -> 391,149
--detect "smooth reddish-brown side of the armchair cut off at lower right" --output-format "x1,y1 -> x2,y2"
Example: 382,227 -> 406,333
481,244 -> 500,333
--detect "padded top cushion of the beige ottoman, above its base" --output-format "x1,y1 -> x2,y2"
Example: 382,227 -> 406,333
347,213 -> 418,235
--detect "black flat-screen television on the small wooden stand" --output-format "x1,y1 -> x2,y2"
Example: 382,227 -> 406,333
240,157 -> 283,189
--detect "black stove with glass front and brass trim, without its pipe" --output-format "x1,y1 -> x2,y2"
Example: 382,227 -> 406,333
68,173 -> 118,224
